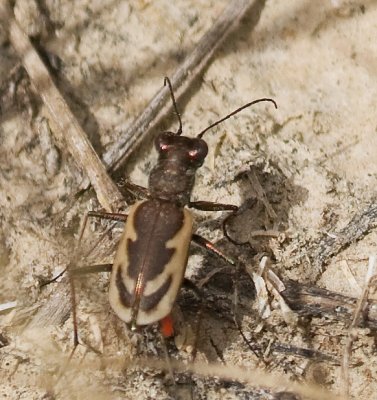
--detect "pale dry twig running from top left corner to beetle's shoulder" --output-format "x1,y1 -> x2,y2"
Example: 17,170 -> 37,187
0,0 -> 124,211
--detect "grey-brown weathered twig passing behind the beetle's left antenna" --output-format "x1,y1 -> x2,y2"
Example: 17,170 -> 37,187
103,0 -> 265,170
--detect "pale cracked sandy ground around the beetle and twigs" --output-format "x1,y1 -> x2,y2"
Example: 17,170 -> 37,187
0,0 -> 377,400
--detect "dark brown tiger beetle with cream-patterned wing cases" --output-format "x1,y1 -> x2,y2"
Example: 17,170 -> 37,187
76,78 -> 277,336
